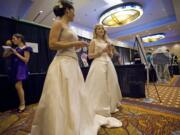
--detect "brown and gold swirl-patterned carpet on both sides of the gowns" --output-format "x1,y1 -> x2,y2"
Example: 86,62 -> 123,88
0,101 -> 180,135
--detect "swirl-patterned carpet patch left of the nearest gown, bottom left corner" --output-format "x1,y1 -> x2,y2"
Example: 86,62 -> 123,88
0,105 -> 36,135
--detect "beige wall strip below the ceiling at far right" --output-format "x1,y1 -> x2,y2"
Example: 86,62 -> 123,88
145,43 -> 180,61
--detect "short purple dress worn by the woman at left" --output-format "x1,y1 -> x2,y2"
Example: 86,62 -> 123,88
9,46 -> 32,83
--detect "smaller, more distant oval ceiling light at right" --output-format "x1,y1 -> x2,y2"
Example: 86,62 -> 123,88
142,33 -> 165,43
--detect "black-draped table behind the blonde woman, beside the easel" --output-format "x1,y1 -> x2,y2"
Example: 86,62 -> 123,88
82,64 -> 146,98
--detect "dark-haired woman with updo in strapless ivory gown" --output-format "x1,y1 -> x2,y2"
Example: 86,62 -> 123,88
31,1 -> 100,135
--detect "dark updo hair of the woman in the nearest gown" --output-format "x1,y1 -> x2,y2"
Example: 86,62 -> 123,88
53,0 -> 74,17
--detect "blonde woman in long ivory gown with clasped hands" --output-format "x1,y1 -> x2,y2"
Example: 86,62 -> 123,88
85,25 -> 122,127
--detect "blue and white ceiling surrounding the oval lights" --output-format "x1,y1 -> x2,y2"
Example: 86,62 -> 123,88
0,0 -> 180,45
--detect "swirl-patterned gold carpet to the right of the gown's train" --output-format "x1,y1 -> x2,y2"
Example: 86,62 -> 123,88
98,105 -> 180,135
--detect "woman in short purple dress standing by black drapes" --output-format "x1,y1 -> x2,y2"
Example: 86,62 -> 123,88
3,33 -> 32,112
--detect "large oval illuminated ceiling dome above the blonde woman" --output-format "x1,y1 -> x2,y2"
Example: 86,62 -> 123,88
100,2 -> 143,27
